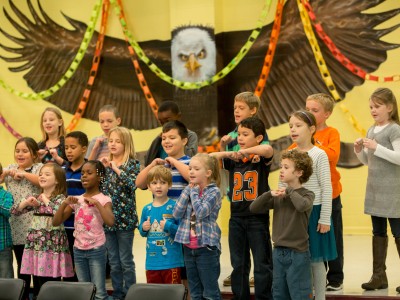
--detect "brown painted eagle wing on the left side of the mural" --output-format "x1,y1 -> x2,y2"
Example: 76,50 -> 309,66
0,0 -> 172,130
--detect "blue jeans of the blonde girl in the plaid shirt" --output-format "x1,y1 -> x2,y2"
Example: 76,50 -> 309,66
183,246 -> 221,300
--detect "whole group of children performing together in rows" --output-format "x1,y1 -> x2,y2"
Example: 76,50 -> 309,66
0,89 -> 400,300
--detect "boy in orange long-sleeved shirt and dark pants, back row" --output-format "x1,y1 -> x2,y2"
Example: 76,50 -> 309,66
289,93 -> 344,291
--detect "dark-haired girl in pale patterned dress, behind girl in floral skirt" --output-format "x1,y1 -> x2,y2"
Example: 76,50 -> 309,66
0,137 -> 42,299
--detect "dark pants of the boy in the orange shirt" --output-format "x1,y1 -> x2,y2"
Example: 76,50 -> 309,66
326,196 -> 344,283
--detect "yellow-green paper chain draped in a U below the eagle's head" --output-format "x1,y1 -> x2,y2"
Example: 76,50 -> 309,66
111,0 -> 271,90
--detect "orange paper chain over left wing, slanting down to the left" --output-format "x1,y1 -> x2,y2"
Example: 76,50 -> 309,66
66,0 -> 110,132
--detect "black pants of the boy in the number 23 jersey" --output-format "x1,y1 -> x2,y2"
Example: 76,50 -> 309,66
229,215 -> 272,300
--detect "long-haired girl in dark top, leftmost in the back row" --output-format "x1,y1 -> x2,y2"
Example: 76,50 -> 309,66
38,107 -> 67,166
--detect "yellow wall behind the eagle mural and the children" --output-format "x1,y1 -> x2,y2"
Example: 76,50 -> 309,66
0,0 -> 400,234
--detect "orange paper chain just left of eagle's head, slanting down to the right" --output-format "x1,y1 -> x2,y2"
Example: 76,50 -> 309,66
117,0 -> 158,119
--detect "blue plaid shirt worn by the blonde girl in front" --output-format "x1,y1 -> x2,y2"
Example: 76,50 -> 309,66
173,183 -> 221,250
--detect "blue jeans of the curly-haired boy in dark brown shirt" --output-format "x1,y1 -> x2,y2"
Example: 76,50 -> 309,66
272,247 -> 312,300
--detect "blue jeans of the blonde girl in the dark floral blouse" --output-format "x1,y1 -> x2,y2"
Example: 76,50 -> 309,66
106,230 -> 136,299
